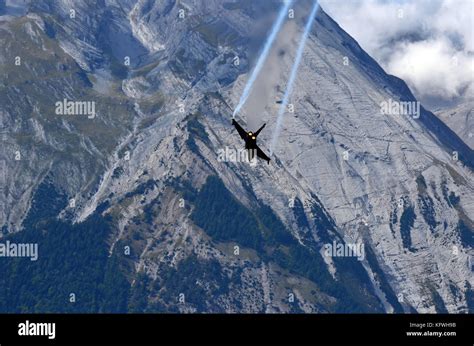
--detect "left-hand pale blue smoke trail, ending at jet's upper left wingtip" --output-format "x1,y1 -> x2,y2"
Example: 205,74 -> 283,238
232,0 -> 293,118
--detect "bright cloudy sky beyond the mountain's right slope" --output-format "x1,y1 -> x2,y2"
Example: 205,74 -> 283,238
320,0 -> 474,109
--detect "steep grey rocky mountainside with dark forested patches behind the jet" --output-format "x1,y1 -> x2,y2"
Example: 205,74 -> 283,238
0,1 -> 474,313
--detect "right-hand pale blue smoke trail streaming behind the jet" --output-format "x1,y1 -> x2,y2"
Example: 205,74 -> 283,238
270,0 -> 319,155
